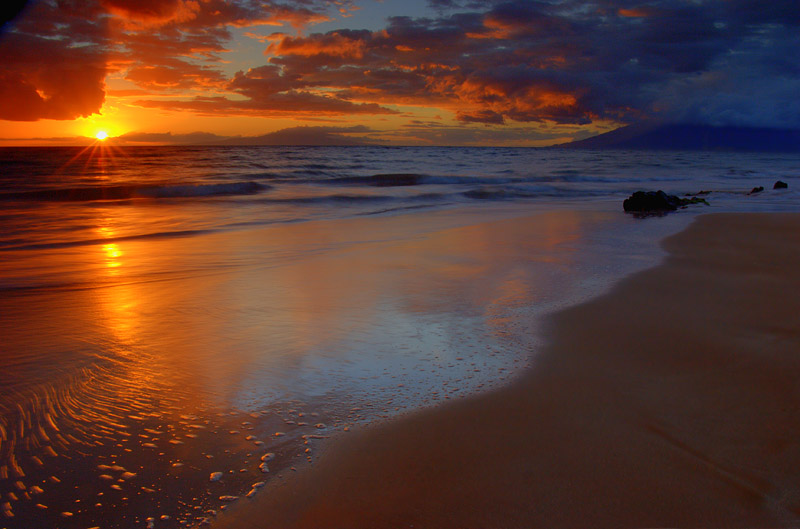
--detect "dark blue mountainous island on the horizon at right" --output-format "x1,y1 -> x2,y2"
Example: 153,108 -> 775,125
557,123 -> 800,152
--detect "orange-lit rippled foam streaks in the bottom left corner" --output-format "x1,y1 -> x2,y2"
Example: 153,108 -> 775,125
0,352 -> 260,529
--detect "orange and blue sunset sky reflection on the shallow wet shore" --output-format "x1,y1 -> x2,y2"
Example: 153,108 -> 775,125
0,205 -> 616,526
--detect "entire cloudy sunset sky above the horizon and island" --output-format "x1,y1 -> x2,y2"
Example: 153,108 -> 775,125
0,0 -> 800,146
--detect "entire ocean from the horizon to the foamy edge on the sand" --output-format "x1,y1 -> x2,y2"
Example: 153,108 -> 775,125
0,144 -> 800,529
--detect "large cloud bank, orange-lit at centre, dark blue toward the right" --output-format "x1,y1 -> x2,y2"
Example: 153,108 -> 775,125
243,0 -> 800,126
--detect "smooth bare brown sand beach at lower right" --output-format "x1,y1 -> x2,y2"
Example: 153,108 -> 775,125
215,214 -> 800,529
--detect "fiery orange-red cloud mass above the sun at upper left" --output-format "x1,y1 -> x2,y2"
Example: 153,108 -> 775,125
0,0 -> 366,121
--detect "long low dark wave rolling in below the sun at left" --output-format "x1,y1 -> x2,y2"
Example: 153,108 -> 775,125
0,182 -> 271,202
